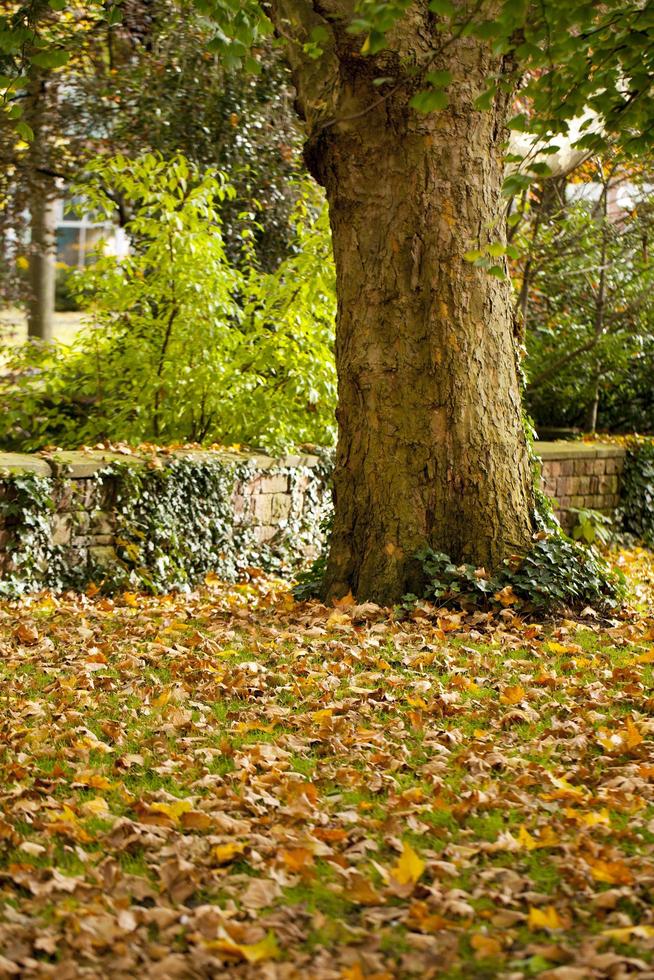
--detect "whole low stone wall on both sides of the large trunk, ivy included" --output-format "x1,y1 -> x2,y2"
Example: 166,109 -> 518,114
0,442 -> 625,594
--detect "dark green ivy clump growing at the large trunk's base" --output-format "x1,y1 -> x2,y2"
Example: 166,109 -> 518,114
418,532 -> 625,613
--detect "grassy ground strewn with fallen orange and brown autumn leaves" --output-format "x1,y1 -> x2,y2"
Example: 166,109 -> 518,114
0,552 -> 654,980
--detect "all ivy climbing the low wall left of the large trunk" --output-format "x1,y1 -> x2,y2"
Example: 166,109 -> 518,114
0,456 -> 331,596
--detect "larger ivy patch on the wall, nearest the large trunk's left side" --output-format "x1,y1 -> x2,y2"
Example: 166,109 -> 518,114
102,459 -> 328,592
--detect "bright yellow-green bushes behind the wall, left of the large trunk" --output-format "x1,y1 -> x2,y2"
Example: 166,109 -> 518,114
0,154 -> 335,450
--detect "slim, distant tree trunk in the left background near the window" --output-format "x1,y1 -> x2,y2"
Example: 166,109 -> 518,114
27,185 -> 57,341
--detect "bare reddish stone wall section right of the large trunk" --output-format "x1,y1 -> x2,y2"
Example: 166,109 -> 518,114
535,442 -> 626,529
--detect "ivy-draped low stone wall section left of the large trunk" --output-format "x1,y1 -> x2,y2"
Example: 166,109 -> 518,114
0,450 -> 329,594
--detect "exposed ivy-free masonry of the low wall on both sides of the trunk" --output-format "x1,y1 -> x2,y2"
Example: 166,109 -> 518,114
0,442 -> 625,584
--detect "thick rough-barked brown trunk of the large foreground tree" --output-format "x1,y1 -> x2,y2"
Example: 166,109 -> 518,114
271,0 -> 533,603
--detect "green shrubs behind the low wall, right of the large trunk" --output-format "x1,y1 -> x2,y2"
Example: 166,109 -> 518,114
515,172 -> 654,431
